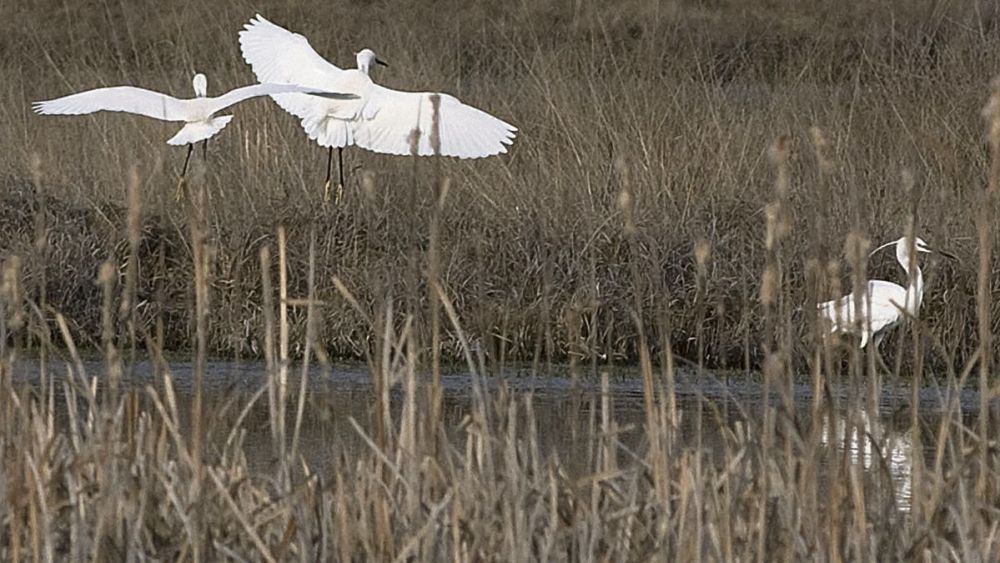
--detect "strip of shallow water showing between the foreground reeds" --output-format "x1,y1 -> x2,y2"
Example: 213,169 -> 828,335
14,361 -> 979,510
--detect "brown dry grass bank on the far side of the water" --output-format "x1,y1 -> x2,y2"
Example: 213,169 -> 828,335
0,2 -> 1000,368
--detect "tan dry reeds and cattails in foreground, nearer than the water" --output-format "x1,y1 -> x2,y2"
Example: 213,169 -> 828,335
0,120 -> 1000,561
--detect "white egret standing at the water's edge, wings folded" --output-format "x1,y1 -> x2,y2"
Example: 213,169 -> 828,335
817,237 -> 954,348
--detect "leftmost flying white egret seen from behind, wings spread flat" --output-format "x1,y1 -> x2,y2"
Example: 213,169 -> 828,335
32,73 -> 353,178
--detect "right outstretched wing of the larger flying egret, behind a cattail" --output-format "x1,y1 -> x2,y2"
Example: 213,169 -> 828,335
354,85 -> 517,158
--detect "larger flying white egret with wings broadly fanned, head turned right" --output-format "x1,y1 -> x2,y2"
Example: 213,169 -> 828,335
240,14 -> 517,203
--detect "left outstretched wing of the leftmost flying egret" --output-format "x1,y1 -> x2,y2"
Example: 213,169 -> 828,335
32,86 -> 187,121
